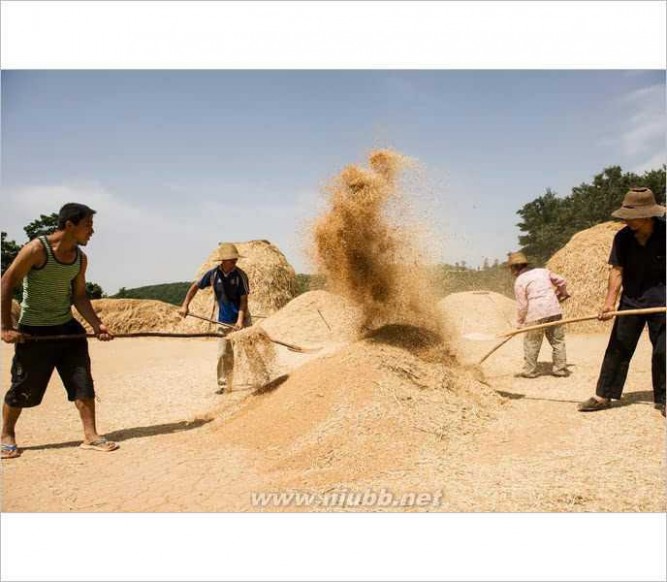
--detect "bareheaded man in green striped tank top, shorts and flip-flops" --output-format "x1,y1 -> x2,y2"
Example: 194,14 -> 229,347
1,203 -> 118,459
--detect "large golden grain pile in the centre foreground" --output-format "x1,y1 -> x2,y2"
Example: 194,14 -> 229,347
217,326 -> 502,489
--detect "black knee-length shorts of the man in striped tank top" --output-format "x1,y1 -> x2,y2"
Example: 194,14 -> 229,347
5,319 -> 95,408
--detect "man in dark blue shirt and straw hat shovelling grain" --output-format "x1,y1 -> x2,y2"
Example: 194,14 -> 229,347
179,243 -> 250,394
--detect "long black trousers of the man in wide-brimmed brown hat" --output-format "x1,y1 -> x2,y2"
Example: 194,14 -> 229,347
595,313 -> 665,404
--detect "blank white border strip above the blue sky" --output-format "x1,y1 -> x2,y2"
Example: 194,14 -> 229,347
1,0 -> 667,69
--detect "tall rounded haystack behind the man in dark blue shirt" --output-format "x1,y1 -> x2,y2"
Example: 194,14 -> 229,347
179,240 -> 296,332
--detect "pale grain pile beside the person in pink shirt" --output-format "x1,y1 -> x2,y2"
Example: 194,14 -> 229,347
438,291 -> 516,364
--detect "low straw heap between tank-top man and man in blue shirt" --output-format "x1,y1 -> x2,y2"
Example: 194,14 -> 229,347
73,299 -> 182,334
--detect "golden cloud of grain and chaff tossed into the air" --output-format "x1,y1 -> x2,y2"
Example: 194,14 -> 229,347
312,150 -> 444,338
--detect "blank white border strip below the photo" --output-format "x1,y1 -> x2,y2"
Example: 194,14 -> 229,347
1,513 -> 667,582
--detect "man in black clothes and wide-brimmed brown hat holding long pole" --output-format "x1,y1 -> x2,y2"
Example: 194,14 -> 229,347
579,188 -> 665,416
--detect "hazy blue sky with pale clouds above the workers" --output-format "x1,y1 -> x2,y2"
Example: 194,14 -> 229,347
2,70 -> 667,293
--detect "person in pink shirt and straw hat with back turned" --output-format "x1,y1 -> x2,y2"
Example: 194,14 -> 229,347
507,253 -> 569,378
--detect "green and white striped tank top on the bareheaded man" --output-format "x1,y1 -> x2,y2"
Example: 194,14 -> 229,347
19,236 -> 81,325
